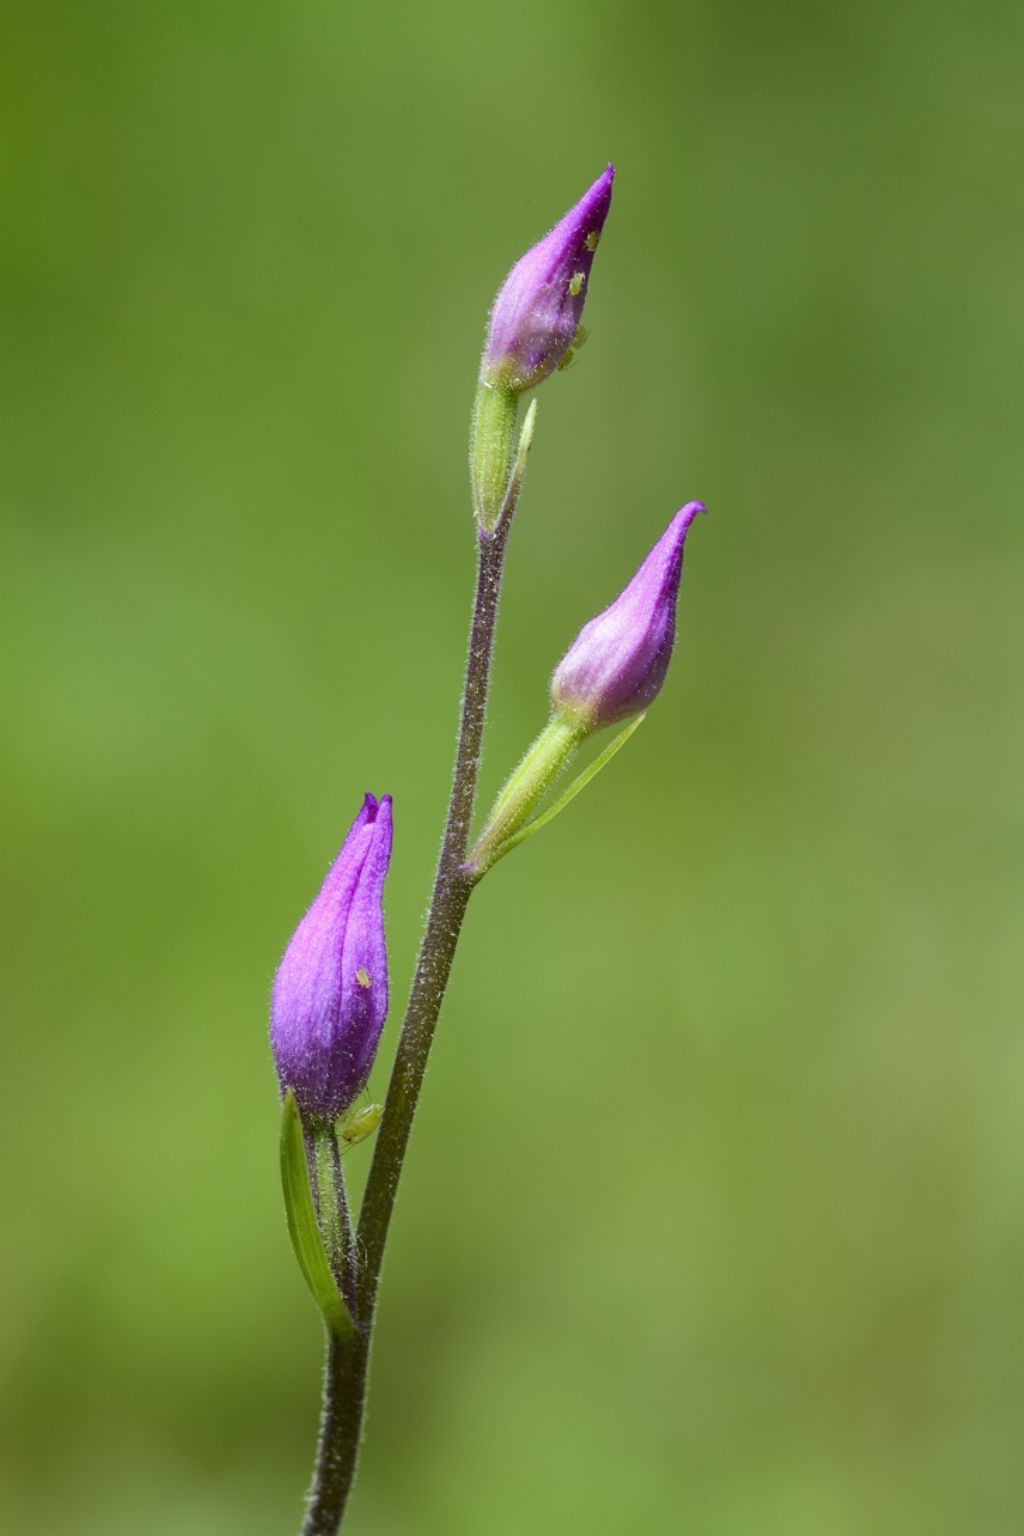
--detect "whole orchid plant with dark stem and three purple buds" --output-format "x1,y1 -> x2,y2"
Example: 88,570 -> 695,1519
270,166 -> 705,1536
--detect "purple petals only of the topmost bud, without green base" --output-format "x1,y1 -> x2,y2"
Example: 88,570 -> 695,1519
481,166 -> 616,393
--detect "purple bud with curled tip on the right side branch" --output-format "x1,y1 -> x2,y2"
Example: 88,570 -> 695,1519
551,501 -> 708,731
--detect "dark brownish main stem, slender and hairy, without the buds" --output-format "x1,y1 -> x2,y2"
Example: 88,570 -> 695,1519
302,522 -> 522,1536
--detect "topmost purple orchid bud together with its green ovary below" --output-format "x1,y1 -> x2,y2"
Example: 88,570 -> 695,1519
470,166 -> 616,535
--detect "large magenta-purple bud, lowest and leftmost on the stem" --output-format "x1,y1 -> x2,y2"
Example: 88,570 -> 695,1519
270,794 -> 391,1120
